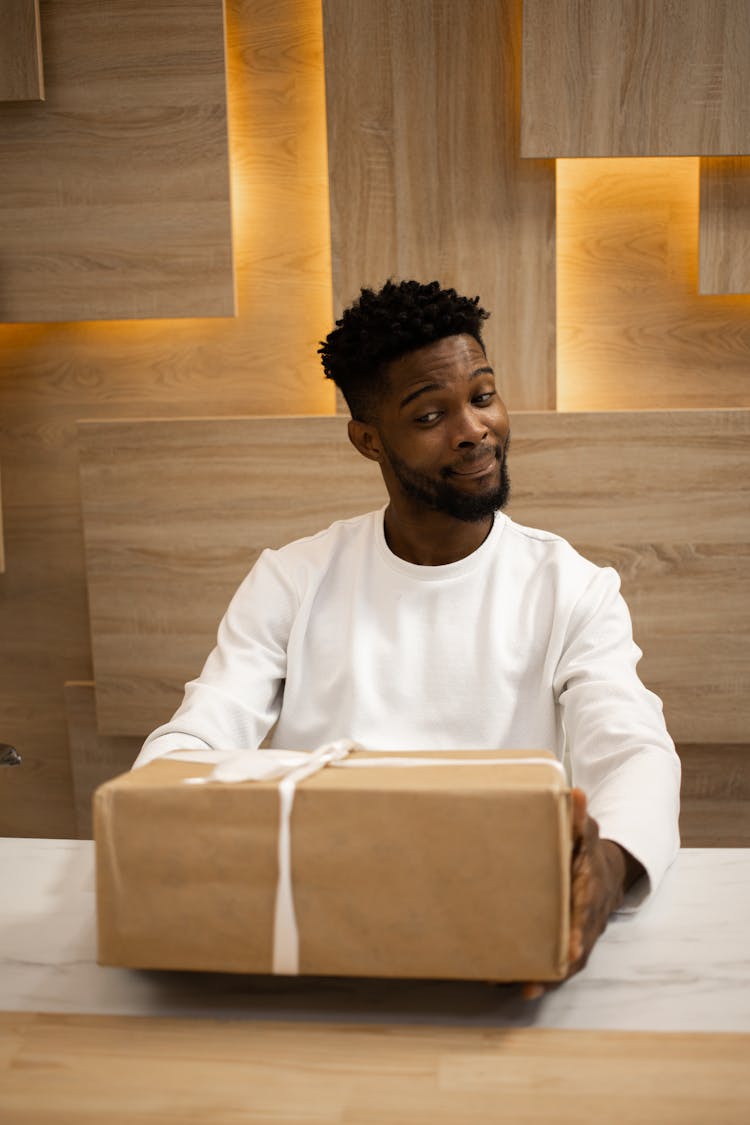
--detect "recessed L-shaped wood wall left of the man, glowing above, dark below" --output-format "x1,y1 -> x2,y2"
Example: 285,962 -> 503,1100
0,0 -> 333,838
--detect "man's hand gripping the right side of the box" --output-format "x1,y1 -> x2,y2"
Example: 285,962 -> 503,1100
523,789 -> 644,1000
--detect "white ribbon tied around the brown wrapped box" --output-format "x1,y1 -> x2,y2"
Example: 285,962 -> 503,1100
165,739 -> 566,977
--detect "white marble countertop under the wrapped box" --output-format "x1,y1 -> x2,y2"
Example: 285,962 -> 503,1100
0,838 -> 750,1032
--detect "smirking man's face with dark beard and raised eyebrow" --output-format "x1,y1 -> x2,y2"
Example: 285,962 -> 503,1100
368,335 -> 509,522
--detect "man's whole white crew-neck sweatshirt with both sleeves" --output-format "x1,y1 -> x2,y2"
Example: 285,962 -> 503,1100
136,510 -> 680,898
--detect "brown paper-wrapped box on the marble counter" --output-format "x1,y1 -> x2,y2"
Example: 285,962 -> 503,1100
94,752 -> 570,981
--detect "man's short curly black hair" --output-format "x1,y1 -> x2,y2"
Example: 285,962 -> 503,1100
318,280 -> 489,422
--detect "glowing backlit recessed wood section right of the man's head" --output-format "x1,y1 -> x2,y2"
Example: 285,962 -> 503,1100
557,163 -> 750,411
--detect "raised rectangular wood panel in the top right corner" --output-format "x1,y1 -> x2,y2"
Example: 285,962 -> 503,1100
522,0 -> 750,156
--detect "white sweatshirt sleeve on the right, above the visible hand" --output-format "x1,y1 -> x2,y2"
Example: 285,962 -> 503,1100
554,569 -> 680,909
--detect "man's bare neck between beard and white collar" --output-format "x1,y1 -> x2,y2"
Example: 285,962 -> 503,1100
383,500 -> 495,566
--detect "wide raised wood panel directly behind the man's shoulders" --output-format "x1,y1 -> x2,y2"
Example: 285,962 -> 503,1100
80,411 -> 750,743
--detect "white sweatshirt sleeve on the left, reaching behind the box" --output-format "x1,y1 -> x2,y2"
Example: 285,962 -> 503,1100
135,551 -> 297,766
